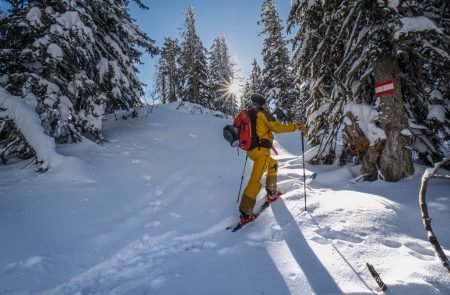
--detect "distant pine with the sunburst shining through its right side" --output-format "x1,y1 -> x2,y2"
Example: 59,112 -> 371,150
208,34 -> 237,115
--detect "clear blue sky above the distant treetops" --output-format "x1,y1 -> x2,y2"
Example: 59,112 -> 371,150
131,0 -> 290,91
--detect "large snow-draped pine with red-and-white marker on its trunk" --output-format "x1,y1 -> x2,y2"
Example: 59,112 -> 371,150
288,1 -> 449,180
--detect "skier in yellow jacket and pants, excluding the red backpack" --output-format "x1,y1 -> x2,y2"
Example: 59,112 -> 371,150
239,93 -> 306,224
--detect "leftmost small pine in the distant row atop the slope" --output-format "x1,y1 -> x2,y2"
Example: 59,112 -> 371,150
156,38 -> 181,103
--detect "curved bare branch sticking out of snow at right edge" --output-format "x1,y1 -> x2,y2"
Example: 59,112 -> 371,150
419,158 -> 450,274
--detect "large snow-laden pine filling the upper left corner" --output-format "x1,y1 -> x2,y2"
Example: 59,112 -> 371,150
0,0 -> 98,150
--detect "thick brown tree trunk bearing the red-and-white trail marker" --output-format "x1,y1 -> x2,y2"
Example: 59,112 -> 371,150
373,56 -> 414,181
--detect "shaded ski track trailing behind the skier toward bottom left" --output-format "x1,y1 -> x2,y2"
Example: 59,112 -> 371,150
45,221 -> 227,294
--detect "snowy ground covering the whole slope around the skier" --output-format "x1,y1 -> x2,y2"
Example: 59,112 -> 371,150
0,104 -> 450,295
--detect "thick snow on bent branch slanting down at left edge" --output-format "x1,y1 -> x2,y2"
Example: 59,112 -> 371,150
0,87 -> 63,171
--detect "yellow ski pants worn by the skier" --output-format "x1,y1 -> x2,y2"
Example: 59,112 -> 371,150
239,147 -> 278,215
